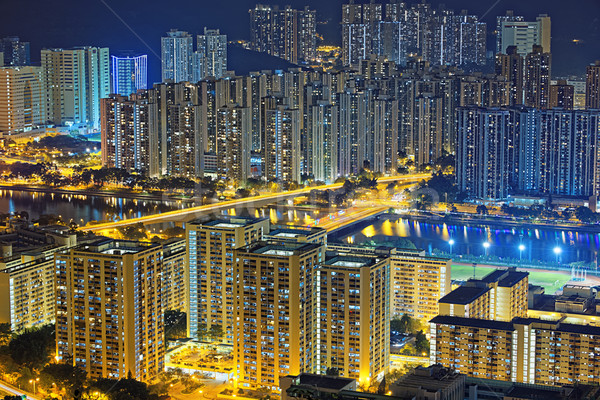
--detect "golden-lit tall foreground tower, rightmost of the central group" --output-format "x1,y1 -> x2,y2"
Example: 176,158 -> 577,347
312,255 -> 391,385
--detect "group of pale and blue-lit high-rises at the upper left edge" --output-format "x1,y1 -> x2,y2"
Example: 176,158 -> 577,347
0,37 -> 147,136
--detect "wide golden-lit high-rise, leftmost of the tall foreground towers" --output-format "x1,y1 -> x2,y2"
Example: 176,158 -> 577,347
55,239 -> 165,382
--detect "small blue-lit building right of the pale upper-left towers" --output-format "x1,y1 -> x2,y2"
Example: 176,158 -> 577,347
111,54 -> 148,96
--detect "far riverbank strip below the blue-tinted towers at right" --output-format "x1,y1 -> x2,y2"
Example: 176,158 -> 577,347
394,212 -> 600,233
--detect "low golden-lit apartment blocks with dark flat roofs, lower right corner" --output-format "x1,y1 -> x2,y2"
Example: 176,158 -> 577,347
430,268 -> 600,386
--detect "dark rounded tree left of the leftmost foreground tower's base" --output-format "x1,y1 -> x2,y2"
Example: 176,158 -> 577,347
8,325 -> 55,369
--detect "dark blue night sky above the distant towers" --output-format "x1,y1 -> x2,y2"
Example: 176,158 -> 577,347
0,0 -> 600,81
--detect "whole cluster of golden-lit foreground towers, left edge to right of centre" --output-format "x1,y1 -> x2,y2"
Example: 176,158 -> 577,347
0,215 -> 450,392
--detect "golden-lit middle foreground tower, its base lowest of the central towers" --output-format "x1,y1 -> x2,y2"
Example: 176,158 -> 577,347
233,242 -> 324,392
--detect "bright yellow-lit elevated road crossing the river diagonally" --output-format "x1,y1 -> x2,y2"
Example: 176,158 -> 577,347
86,174 -> 431,232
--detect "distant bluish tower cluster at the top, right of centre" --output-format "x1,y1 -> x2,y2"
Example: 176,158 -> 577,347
342,0 -> 487,67
